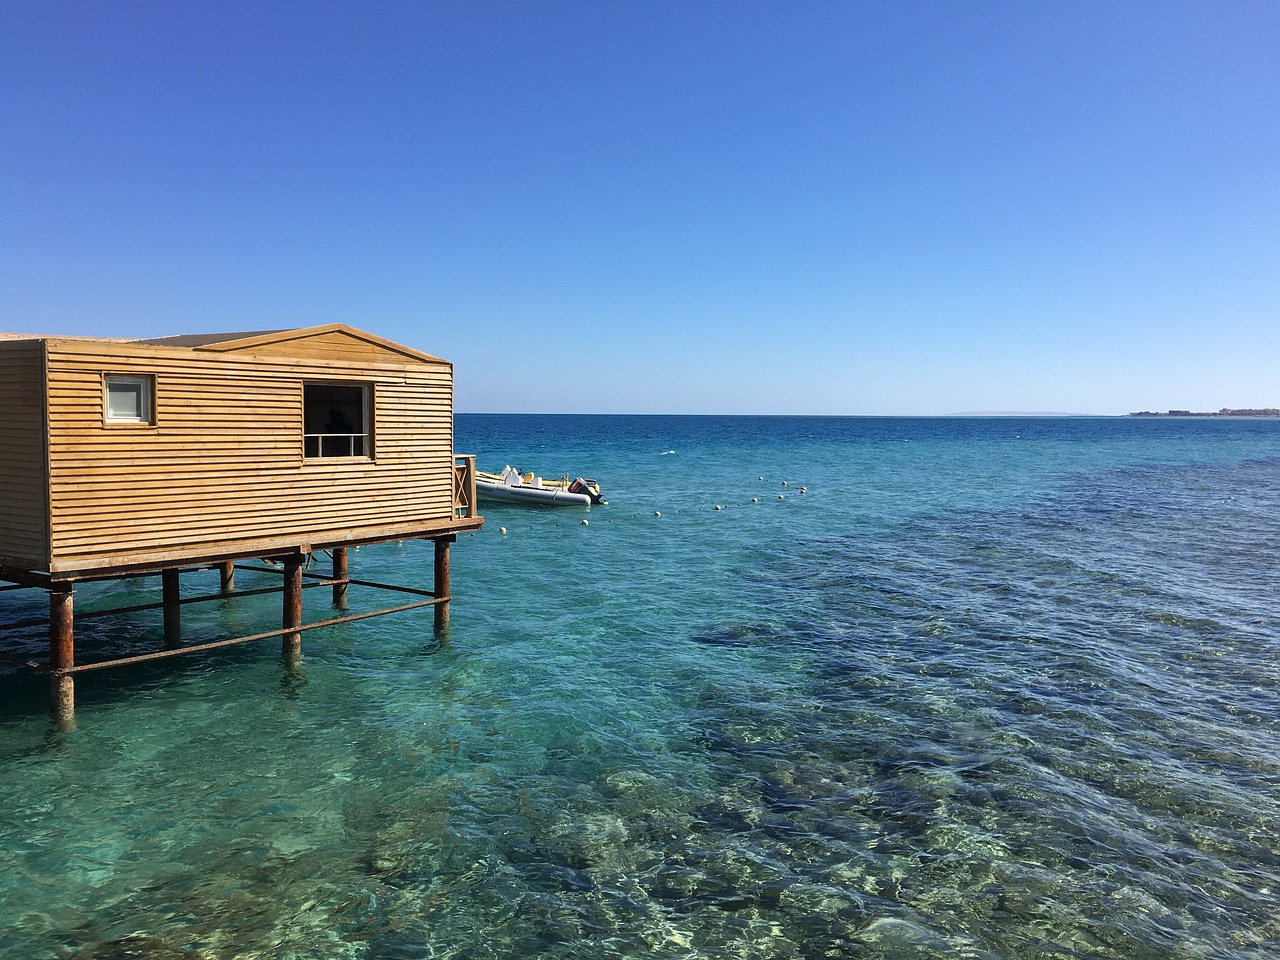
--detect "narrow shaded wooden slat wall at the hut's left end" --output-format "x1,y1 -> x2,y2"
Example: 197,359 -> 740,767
0,339 -> 49,570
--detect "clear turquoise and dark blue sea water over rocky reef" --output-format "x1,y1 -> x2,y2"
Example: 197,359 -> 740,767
0,415 -> 1280,960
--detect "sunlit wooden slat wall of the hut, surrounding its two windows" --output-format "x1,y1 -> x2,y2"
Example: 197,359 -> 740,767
49,340 -> 453,571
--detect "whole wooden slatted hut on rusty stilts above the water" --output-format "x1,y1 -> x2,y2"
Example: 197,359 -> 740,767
0,324 -> 484,721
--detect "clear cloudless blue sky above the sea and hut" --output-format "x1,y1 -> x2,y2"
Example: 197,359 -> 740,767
0,0 -> 1280,413
